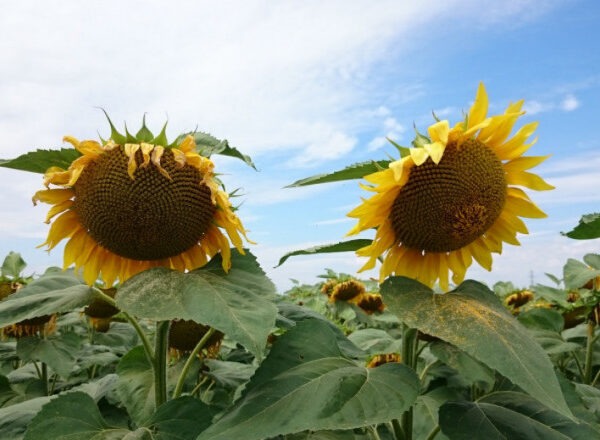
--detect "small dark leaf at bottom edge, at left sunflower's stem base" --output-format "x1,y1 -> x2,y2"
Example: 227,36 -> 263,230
149,396 -> 213,440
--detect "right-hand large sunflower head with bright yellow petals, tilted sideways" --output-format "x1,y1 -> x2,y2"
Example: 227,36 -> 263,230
348,84 -> 553,290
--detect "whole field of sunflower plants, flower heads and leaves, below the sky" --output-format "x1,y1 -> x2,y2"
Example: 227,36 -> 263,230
0,84 -> 600,440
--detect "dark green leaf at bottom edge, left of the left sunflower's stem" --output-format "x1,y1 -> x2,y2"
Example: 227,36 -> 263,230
24,391 -> 152,440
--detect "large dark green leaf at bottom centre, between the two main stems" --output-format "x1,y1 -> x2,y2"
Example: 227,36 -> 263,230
198,319 -> 420,440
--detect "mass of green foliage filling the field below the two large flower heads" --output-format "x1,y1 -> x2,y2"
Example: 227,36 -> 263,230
0,248 -> 600,440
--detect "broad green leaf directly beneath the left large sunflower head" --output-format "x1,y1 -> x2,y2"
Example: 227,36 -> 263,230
116,251 -> 277,359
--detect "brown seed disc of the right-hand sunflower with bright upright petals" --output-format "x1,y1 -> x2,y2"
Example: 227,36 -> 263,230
390,139 -> 506,252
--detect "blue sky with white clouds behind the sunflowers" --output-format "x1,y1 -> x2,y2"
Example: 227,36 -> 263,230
0,0 -> 600,291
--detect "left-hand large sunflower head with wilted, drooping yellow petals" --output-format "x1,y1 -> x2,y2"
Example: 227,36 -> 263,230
33,119 -> 248,287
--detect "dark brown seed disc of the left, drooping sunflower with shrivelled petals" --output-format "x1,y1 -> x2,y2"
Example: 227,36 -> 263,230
73,146 -> 216,260
